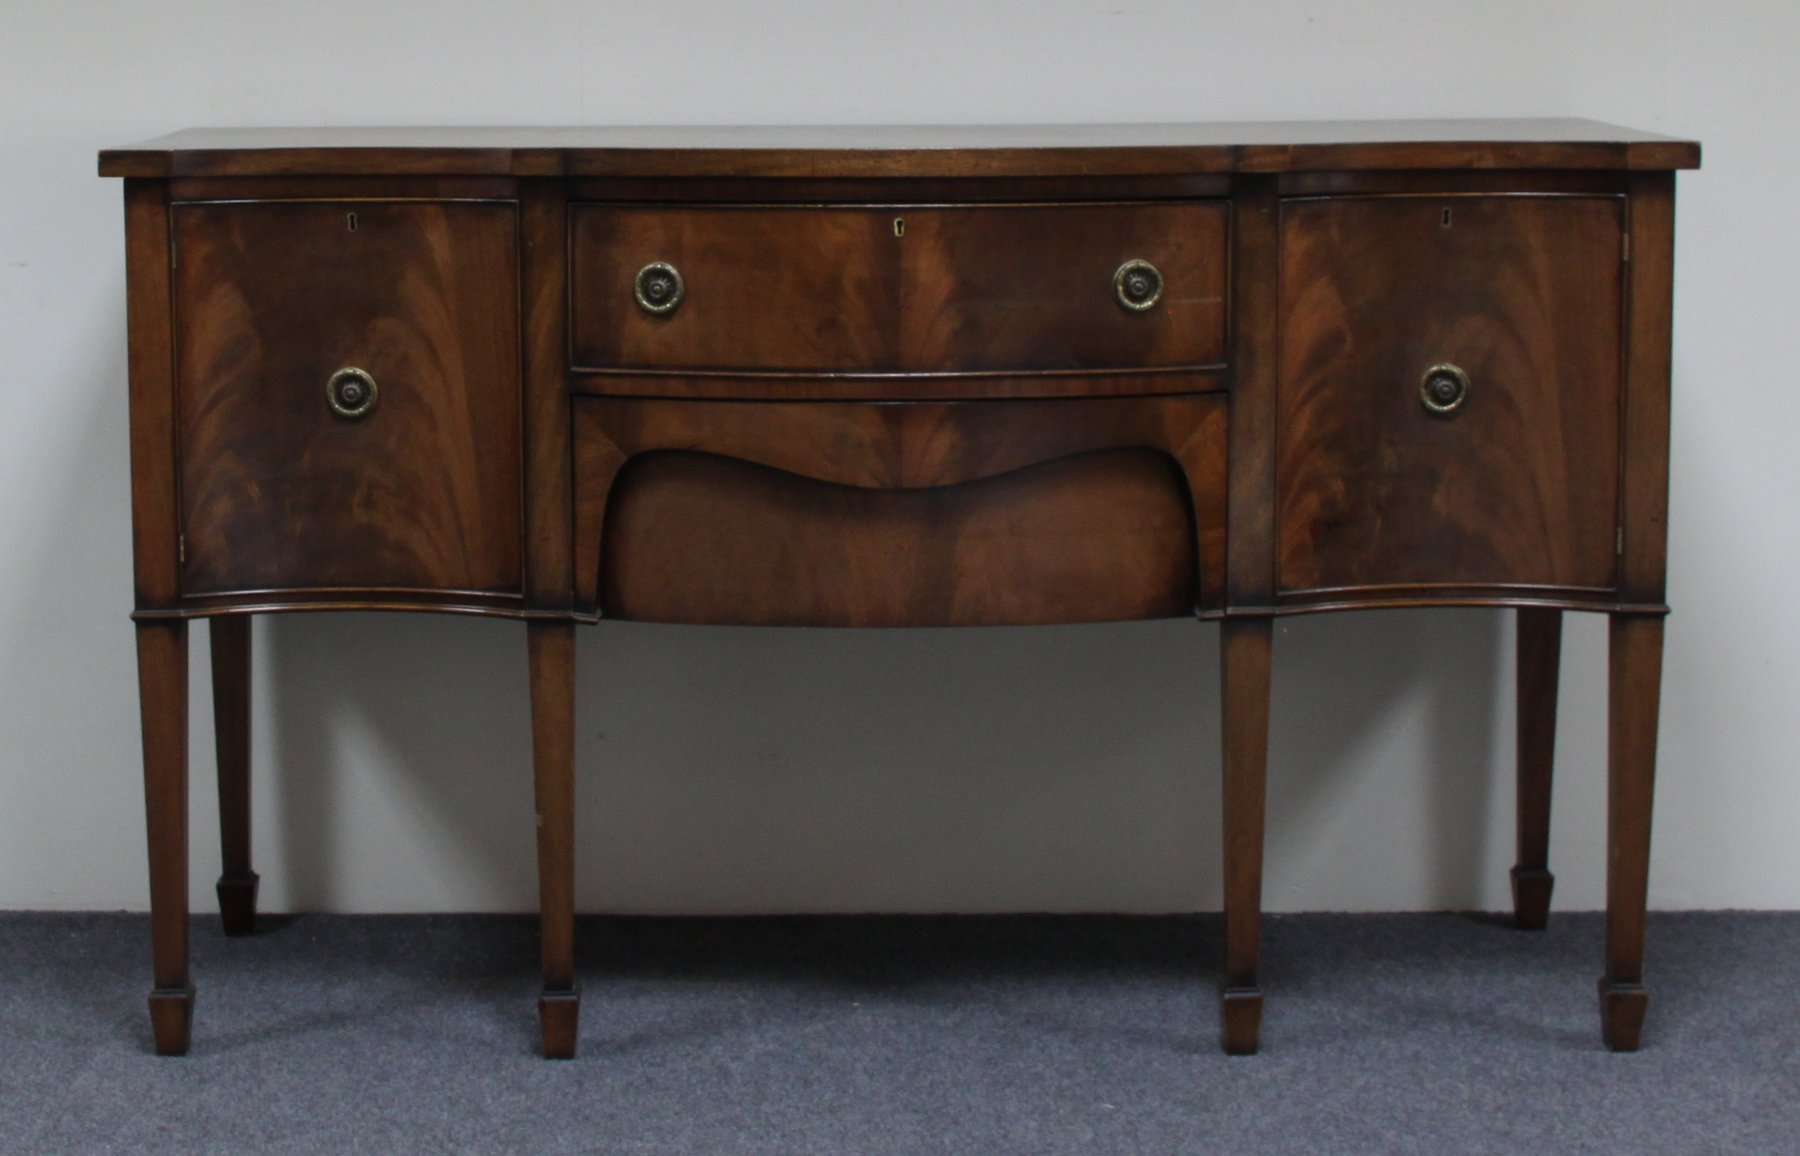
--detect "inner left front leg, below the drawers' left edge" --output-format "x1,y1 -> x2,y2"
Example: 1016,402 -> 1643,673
527,621 -> 581,1059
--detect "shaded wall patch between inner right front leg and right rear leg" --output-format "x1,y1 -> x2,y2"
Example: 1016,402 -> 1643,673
1264,609 -> 1514,911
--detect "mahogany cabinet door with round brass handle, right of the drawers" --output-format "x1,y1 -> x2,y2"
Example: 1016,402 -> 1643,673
1276,194 -> 1625,601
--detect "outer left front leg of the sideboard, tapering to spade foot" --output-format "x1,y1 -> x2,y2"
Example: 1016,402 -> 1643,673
137,619 -> 194,1055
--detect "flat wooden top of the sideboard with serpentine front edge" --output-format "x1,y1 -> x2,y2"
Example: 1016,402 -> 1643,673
99,119 -> 1699,178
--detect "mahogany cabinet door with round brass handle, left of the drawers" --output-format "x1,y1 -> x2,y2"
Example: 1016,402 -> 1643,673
173,200 -> 522,600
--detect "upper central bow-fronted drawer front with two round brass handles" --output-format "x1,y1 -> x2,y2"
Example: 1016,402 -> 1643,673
571,202 -> 1228,375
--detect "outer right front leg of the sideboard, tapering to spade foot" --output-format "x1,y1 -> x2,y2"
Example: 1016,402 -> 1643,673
1600,614 -> 1663,1052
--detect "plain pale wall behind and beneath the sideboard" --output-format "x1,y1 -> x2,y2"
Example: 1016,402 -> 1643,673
0,0 -> 1800,911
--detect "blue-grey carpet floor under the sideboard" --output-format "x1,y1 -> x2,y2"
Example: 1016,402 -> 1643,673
0,913 -> 1800,1156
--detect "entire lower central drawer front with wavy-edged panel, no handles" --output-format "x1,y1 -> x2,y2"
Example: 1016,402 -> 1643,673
574,394 -> 1228,627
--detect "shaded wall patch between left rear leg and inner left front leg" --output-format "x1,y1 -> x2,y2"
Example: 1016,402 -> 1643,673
262,614 -> 536,911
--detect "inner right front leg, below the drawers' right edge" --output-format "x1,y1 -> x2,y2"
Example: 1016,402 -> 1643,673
1220,618 -> 1271,1055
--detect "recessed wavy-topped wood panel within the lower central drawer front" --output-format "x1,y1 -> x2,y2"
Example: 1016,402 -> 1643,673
601,450 -> 1195,627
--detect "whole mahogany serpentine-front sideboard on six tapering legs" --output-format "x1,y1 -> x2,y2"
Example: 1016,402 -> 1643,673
99,121 -> 1699,1057
